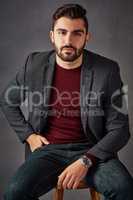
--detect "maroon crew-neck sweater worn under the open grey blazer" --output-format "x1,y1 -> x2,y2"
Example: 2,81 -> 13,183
45,65 -> 95,164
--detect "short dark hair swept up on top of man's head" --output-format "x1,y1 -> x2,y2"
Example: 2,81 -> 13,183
52,4 -> 88,32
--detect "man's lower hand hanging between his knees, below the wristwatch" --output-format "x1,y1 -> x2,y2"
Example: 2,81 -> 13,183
57,160 -> 89,189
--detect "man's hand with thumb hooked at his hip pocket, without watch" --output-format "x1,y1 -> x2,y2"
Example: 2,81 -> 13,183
26,133 -> 49,152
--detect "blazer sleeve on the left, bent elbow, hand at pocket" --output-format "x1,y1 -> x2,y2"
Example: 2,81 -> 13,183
0,55 -> 34,143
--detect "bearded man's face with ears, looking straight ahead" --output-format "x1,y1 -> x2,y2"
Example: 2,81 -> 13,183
50,17 -> 89,62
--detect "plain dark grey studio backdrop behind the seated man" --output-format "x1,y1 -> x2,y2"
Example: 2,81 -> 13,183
0,0 -> 133,200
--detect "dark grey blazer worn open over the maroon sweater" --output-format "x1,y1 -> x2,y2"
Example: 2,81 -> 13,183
0,50 -> 130,160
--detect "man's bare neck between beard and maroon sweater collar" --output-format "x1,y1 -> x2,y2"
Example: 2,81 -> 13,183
56,54 -> 83,69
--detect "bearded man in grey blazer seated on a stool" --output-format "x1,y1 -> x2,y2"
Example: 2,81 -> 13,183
1,4 -> 133,200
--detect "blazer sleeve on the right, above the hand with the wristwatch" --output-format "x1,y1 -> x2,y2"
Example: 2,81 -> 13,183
86,63 -> 130,160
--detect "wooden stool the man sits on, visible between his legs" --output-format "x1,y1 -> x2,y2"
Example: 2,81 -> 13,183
53,181 -> 100,200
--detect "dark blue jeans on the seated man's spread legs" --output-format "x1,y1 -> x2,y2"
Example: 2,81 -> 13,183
4,143 -> 133,200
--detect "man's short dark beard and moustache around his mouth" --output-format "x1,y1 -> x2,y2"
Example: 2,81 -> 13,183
53,43 -> 85,62
